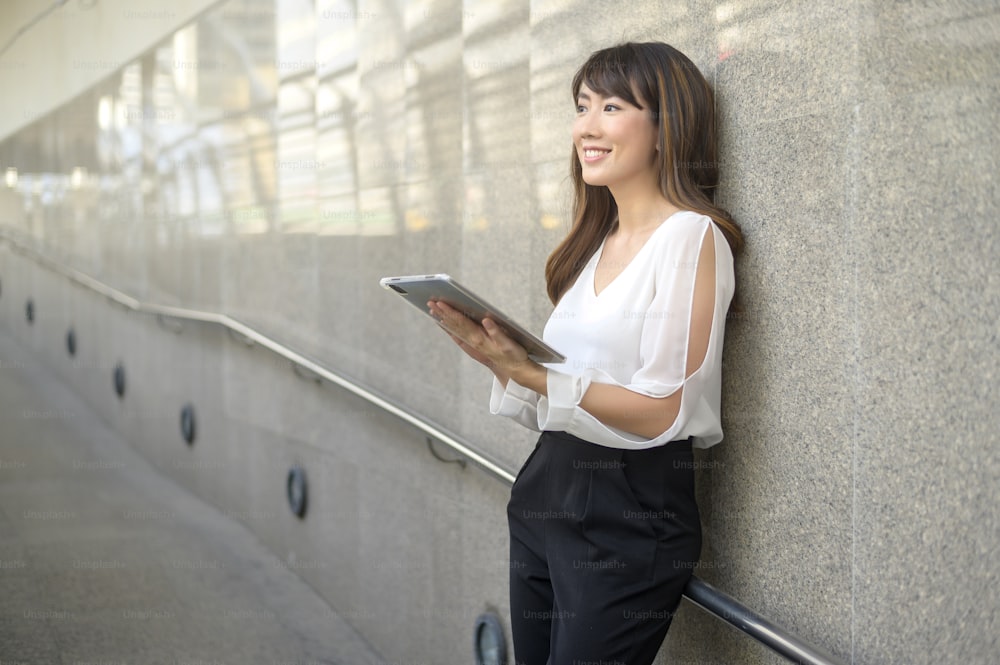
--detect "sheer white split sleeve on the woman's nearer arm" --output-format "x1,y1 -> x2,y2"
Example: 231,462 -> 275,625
537,217 -> 732,449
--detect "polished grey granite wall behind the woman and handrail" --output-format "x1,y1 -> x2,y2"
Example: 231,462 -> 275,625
0,0 -> 1000,665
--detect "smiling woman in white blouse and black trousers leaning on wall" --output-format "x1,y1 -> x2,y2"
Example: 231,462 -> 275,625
428,43 -> 742,665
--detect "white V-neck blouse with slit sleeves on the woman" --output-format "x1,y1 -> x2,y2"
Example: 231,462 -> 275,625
490,210 -> 735,449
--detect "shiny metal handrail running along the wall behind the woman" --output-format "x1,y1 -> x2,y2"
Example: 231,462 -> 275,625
0,228 -> 847,665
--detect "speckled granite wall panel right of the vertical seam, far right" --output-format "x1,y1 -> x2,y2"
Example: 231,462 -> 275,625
855,24 -> 1000,662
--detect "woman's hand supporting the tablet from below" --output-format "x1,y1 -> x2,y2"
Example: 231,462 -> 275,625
427,300 -> 535,383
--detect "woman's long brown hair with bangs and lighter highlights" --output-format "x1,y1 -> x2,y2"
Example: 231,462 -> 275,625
545,42 -> 743,304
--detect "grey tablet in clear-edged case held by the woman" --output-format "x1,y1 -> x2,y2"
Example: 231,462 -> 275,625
379,275 -> 566,363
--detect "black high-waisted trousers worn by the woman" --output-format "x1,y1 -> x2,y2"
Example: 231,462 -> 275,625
507,432 -> 701,665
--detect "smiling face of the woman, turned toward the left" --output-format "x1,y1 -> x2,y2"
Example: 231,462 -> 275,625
573,84 -> 657,190
